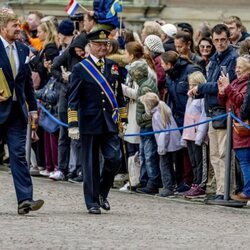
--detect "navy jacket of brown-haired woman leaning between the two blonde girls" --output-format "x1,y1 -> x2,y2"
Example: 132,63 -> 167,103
166,57 -> 201,127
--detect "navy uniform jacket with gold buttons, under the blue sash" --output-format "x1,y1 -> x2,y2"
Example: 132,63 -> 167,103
68,57 -> 124,135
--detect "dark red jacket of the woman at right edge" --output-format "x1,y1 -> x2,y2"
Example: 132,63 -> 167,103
218,74 -> 250,149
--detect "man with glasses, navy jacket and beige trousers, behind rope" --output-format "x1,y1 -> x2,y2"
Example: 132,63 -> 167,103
188,24 -> 238,199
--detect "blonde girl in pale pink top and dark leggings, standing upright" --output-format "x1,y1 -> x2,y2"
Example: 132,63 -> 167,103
182,71 -> 208,198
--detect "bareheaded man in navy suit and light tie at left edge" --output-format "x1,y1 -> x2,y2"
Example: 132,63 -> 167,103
0,11 -> 44,214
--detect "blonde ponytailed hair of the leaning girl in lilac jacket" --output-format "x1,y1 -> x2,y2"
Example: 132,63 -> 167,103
140,92 -> 171,128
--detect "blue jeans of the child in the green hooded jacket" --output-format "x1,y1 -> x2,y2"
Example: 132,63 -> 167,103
140,128 -> 161,188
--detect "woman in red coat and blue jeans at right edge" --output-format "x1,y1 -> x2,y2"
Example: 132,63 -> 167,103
218,55 -> 250,201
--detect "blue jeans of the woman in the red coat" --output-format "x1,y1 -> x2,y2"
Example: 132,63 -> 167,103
235,148 -> 250,197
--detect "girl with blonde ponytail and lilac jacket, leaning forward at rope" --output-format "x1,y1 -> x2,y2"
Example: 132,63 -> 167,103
140,92 -> 182,197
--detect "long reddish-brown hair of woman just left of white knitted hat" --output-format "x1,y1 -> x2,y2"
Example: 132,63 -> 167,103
126,41 -> 155,71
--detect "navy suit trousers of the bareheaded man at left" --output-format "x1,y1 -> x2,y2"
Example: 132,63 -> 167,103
0,102 -> 33,202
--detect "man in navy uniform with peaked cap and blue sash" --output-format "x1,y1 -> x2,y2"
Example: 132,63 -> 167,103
68,30 -> 124,214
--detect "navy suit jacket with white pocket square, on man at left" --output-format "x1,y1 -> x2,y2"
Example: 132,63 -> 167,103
0,40 -> 37,124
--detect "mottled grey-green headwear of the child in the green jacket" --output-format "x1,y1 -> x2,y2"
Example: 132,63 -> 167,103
128,60 -> 148,82
